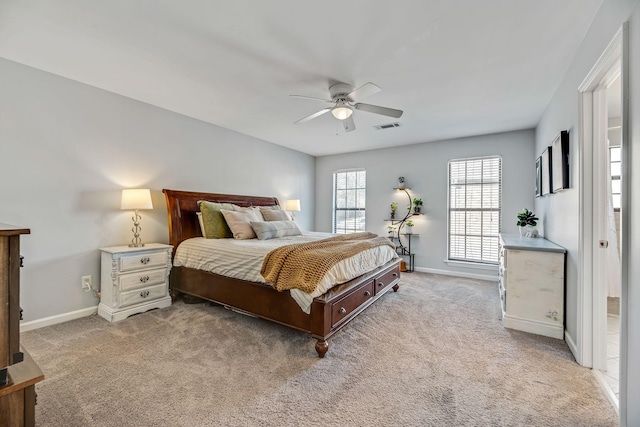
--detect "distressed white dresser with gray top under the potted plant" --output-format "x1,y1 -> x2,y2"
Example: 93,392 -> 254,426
498,234 -> 566,339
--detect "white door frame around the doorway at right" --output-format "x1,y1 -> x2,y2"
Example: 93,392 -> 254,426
575,22 -> 630,416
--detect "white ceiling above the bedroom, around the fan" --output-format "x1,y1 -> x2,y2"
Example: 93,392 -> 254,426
0,0 -> 602,155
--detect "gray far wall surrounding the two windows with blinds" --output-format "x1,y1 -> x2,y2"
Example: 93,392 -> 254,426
316,130 -> 535,277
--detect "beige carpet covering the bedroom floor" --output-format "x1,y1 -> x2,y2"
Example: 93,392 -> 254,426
22,273 -> 618,426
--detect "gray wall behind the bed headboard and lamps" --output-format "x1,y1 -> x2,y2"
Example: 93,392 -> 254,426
0,59 -> 315,321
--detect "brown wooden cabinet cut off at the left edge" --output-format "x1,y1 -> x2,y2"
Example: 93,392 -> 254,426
0,224 -> 44,427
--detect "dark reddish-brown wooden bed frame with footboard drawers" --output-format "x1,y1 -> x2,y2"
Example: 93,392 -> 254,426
162,189 -> 400,357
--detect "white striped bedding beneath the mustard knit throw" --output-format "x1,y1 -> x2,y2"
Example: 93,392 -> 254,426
173,232 -> 398,314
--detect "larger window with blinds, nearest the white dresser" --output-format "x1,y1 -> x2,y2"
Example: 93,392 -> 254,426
449,157 -> 502,264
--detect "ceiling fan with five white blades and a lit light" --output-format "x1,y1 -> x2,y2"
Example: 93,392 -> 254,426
290,82 -> 402,132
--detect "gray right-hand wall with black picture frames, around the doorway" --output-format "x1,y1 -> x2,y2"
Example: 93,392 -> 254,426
536,0 -> 640,426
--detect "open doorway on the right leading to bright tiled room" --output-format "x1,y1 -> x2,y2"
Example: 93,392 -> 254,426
576,24 -> 628,413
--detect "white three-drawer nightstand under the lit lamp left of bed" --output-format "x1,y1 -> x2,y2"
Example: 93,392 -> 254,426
98,243 -> 173,322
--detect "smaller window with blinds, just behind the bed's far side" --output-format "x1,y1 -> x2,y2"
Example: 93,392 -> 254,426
333,169 -> 367,234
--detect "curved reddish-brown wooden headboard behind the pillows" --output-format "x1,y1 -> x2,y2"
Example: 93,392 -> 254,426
162,188 -> 280,252
